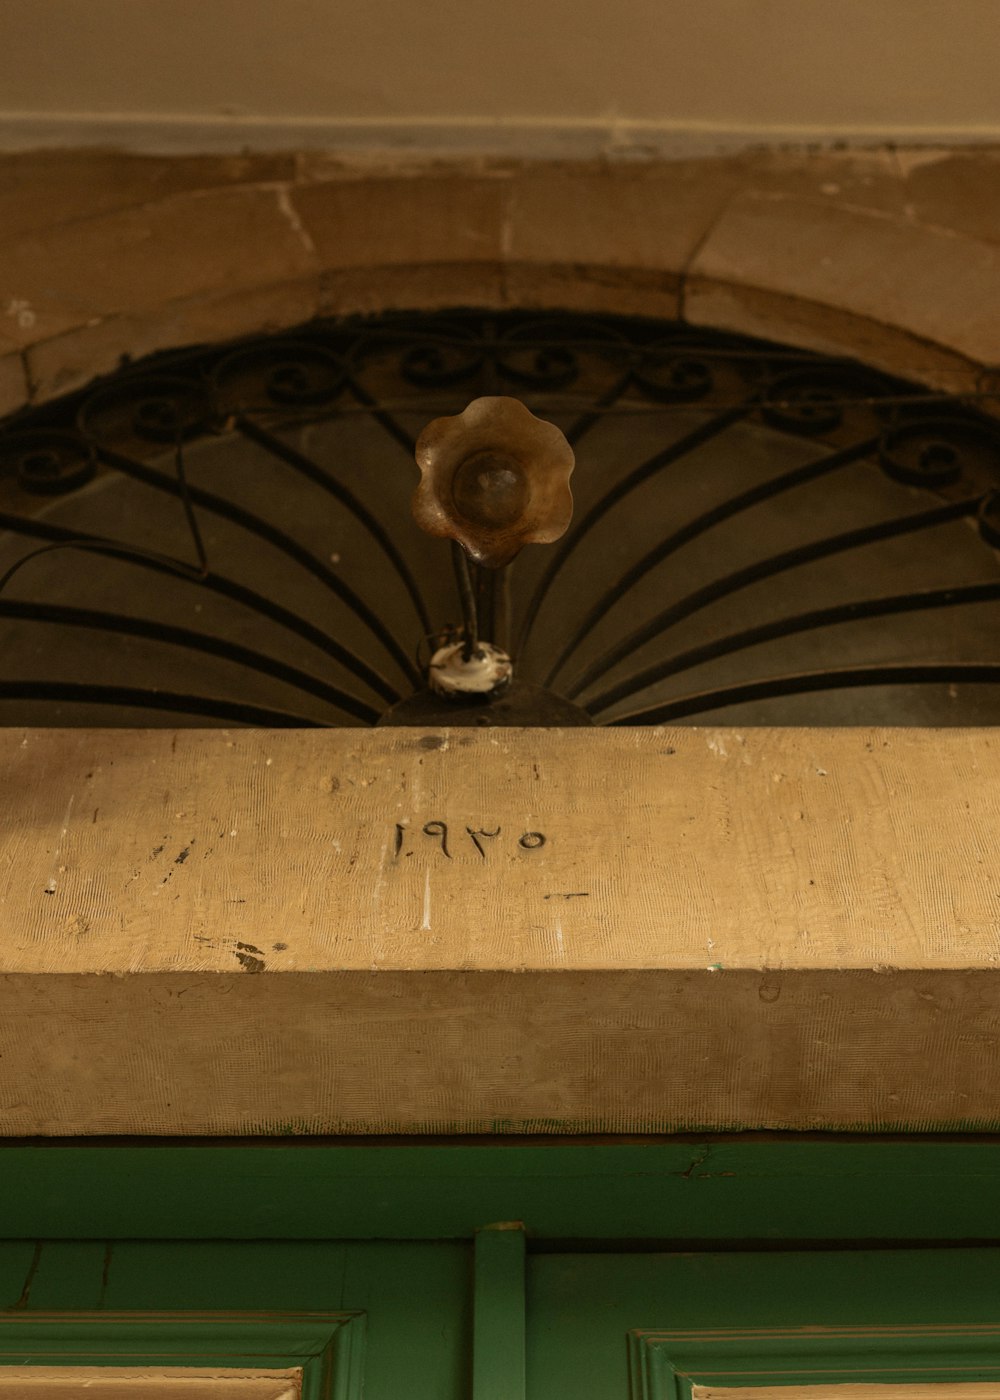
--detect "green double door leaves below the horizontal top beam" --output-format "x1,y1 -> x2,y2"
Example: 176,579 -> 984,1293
0,1228 -> 1000,1400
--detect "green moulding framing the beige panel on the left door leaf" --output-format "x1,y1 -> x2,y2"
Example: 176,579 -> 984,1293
0,1312 -> 364,1400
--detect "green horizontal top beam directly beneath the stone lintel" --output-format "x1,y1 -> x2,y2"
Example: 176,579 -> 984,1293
0,1137 -> 1000,1245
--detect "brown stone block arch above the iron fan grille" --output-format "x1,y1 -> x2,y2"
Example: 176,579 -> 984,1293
0,151 -> 1000,413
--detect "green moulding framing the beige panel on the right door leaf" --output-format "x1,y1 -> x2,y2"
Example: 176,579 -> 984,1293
629,1326 -> 1000,1400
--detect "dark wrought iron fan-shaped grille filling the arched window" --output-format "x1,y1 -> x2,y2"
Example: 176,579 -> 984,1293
0,312 -> 1000,725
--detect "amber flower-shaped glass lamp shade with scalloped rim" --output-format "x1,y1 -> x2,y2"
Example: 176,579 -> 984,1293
413,396 -> 574,568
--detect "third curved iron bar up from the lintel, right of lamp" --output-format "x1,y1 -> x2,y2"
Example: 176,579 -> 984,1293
566,496 -> 983,700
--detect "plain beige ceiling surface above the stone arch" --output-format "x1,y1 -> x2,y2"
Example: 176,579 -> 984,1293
0,0 -> 1000,148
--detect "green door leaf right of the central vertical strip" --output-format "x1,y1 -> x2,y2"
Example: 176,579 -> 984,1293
527,1249 -> 1000,1400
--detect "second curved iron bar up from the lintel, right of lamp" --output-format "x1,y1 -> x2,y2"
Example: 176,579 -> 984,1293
584,581 -> 1000,714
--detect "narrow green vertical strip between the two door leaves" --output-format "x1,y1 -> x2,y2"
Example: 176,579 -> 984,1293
472,1222 -> 525,1400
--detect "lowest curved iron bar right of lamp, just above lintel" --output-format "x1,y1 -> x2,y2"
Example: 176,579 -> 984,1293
609,661 -> 1000,727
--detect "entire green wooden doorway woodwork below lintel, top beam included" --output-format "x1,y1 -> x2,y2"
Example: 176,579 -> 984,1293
0,1141 -> 1000,1400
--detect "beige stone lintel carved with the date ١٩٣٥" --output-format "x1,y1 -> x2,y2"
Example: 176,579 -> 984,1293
0,728 -> 1000,1135
